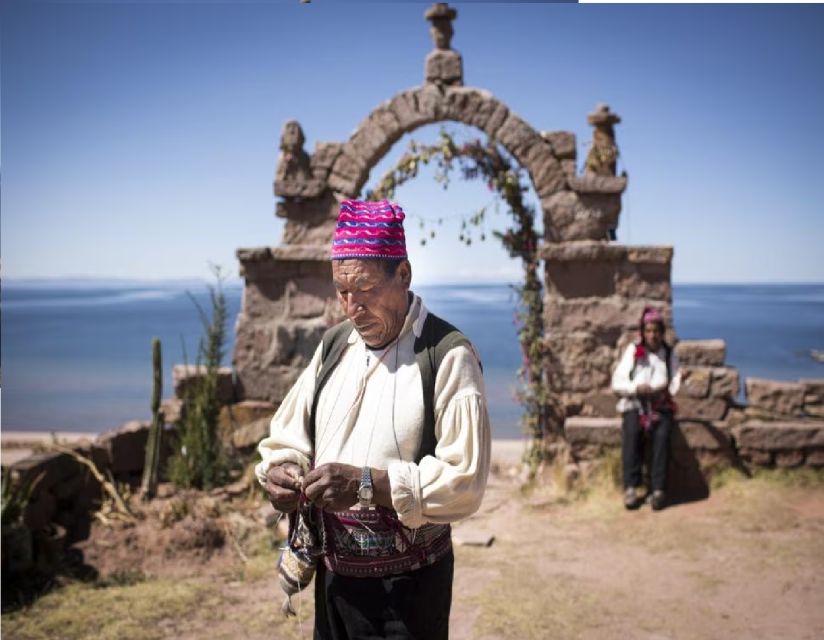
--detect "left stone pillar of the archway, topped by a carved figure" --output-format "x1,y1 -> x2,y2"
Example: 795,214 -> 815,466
233,120 -> 343,405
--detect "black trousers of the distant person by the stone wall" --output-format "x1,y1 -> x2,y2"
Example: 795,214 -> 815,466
621,411 -> 673,491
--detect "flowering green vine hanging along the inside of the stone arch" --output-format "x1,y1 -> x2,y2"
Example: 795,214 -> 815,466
366,130 -> 561,456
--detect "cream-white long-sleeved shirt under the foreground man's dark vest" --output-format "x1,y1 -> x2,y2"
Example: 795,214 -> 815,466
256,296 -> 491,528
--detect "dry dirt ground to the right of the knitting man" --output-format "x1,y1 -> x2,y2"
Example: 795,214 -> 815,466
452,470 -> 824,640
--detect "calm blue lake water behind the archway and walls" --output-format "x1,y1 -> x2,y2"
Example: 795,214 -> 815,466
0,283 -> 824,437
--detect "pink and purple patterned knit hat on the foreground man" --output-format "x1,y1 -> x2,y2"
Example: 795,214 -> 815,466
332,200 -> 407,260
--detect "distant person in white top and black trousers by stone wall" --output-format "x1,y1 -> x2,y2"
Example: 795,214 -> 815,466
612,307 -> 681,511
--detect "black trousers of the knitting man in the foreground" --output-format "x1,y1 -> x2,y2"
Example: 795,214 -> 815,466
314,551 -> 455,640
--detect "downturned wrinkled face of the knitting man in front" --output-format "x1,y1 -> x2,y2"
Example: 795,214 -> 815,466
332,260 -> 412,348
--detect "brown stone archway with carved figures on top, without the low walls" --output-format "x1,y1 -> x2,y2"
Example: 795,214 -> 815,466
234,4 -> 672,436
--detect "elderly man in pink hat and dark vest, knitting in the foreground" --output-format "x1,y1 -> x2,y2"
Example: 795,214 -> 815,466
257,200 -> 490,639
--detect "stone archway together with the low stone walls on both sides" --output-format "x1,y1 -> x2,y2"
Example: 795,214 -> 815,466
6,3 -> 824,539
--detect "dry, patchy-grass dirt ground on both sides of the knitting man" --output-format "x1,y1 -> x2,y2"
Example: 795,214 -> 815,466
2,440 -> 824,640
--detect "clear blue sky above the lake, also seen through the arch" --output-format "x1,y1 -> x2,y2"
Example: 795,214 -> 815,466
0,0 -> 824,282
